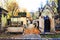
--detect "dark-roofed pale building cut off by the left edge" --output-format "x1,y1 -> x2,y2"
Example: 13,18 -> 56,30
0,7 -> 8,27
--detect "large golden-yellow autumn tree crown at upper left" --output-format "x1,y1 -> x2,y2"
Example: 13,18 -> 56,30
7,2 -> 19,16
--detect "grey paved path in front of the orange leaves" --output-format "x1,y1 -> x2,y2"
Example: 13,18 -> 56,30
12,34 -> 41,40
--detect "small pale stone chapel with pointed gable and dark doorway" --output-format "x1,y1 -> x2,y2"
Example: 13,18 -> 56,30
39,5 -> 55,32
